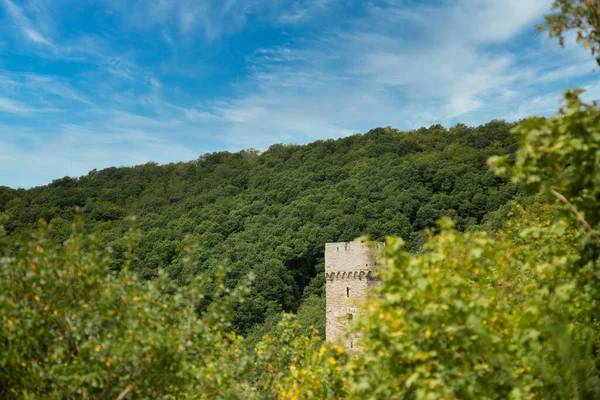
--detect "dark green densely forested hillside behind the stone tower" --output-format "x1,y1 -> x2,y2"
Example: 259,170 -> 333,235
0,121 -> 518,334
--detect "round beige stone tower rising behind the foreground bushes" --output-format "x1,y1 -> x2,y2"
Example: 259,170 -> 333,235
325,242 -> 384,349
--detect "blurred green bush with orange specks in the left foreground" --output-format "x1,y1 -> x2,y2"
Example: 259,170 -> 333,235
0,220 -> 254,399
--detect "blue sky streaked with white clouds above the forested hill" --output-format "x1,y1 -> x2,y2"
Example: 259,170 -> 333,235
0,0 -> 600,187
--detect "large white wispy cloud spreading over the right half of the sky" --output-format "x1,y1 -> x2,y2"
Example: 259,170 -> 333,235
199,0 -> 593,145
